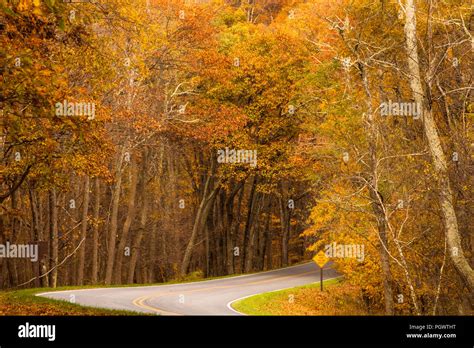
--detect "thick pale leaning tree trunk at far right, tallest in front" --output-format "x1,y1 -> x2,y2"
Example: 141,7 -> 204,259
404,0 -> 474,293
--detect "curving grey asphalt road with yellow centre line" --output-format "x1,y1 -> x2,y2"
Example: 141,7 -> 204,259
37,262 -> 338,315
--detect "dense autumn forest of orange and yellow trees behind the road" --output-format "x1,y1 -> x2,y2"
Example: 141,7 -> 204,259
0,0 -> 474,315
